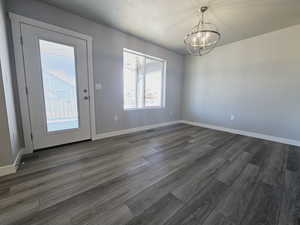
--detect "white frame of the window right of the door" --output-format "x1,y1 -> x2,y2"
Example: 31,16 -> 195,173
123,48 -> 167,111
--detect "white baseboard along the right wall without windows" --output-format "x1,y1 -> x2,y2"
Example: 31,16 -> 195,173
181,120 -> 300,147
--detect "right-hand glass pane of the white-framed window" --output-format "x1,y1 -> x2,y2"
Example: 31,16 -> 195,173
145,59 -> 164,107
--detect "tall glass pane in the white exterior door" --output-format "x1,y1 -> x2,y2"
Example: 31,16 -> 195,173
39,40 -> 79,132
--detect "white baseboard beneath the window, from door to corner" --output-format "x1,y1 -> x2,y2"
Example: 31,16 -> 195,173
93,120 -> 181,140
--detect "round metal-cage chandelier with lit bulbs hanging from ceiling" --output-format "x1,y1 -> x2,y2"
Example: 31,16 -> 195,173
184,6 -> 221,56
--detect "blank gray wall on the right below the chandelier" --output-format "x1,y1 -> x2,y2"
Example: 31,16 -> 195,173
183,25 -> 300,140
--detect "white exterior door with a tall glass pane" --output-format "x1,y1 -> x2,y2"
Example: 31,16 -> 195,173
21,24 -> 91,149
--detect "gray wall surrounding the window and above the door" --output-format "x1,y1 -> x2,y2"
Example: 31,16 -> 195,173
7,0 -> 183,137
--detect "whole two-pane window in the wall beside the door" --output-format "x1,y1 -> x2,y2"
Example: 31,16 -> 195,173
123,49 -> 166,109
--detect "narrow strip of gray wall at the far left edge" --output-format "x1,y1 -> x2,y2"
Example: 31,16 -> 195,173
0,0 -> 20,166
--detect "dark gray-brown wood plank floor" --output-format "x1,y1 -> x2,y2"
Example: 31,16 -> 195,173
0,124 -> 300,225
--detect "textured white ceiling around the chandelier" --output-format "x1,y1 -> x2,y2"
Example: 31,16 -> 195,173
40,0 -> 300,54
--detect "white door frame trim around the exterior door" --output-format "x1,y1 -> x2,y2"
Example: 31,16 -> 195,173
9,13 -> 96,154
